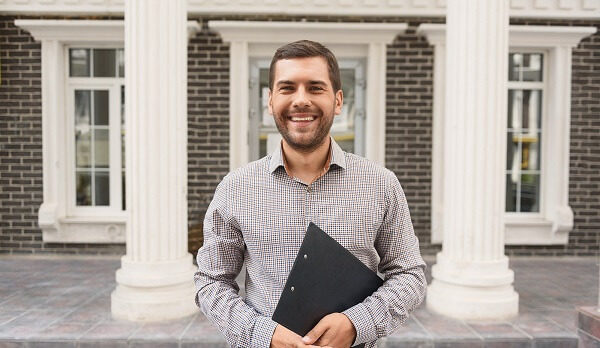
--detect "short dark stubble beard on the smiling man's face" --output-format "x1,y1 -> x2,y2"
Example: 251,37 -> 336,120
275,106 -> 334,153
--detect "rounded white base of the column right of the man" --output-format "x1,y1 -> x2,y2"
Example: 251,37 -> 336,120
427,253 -> 519,321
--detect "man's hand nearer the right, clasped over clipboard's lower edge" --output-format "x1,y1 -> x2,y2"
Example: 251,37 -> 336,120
302,313 -> 356,348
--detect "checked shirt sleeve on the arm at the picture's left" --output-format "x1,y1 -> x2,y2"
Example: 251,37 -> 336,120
194,179 -> 277,348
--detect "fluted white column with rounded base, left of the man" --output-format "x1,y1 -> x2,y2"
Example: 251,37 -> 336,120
112,0 -> 197,321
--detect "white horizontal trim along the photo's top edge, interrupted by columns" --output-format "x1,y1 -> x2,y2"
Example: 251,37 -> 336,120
0,0 -> 600,19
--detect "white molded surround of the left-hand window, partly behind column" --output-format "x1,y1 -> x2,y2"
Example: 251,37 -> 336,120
15,18 -> 199,243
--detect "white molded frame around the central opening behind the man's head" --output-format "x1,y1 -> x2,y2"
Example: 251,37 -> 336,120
208,21 -> 407,170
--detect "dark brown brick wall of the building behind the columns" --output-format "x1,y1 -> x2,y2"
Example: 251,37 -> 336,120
0,16 -> 600,256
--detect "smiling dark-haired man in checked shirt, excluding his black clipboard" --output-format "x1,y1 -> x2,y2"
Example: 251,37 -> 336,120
195,41 -> 426,348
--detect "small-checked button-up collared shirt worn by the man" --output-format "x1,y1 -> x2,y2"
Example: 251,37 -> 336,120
194,139 -> 427,347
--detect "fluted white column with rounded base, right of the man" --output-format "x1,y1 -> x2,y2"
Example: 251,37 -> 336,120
427,0 -> 518,320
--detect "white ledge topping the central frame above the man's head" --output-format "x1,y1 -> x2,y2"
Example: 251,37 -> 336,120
208,21 -> 408,44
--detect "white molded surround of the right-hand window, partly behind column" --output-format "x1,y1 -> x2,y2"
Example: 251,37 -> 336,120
417,23 -> 597,245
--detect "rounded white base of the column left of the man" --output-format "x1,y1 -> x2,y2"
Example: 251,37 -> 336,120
111,254 -> 198,322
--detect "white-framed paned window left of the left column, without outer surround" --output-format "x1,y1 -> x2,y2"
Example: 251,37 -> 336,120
67,47 -> 125,215
